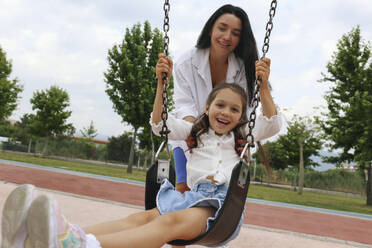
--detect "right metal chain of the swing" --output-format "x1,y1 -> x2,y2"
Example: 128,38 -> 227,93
246,0 -> 277,147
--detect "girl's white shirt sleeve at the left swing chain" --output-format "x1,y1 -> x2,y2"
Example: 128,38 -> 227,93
150,113 -> 192,140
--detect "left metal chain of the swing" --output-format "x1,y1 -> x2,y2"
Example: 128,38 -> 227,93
160,0 -> 170,140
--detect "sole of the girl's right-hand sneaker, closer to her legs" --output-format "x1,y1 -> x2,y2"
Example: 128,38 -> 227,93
25,195 -> 58,248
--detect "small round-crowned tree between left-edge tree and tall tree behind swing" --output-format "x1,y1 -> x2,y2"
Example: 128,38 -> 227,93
30,86 -> 74,154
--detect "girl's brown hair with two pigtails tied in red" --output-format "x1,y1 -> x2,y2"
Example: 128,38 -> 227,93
186,83 -> 248,155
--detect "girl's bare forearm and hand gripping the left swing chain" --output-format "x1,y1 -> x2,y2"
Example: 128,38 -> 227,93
152,53 -> 173,124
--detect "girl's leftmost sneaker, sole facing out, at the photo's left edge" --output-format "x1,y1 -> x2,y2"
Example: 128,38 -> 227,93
1,184 -> 37,248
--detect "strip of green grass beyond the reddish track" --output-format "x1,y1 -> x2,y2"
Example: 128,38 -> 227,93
0,151 -> 372,215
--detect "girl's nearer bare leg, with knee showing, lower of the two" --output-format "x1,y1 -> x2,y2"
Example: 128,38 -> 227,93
96,207 -> 216,248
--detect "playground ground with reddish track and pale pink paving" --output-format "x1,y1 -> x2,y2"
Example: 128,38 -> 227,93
0,161 -> 372,248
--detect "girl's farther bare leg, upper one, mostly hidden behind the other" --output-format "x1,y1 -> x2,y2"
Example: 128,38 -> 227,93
83,208 -> 160,236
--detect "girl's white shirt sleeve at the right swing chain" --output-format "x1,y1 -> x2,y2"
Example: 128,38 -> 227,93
245,107 -> 282,141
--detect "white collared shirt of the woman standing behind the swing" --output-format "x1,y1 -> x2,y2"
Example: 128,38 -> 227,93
170,48 -> 250,151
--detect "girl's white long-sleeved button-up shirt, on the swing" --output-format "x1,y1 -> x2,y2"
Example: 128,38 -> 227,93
150,111 -> 282,189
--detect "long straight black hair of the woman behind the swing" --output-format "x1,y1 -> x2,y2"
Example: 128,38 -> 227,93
196,4 -> 258,104
